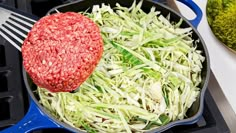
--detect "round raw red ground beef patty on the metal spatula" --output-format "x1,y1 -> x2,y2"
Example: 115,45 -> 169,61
22,12 -> 103,92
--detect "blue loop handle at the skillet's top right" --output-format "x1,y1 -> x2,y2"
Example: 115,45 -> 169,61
178,0 -> 202,28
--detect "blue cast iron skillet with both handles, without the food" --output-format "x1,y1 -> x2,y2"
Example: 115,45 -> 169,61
2,0 -> 210,133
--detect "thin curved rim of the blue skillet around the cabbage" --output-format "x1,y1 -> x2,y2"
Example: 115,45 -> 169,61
22,0 -> 210,132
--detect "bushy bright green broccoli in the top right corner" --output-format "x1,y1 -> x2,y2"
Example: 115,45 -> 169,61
207,0 -> 236,51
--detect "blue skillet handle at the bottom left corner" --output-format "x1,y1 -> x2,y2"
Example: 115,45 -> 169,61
1,98 -> 62,133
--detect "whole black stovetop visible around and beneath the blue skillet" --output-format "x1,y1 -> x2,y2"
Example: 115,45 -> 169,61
0,0 -> 230,133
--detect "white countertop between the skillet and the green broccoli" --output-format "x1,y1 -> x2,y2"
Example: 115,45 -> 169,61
176,0 -> 236,112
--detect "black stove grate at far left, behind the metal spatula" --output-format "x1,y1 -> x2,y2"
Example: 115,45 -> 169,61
0,0 -> 30,130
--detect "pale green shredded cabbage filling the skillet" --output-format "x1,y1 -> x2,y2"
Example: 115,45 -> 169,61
37,2 -> 205,133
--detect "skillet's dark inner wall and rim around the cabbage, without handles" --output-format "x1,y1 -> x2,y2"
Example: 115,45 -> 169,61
23,0 -> 210,132
